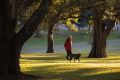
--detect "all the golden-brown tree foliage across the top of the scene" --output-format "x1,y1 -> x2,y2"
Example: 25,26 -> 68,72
16,0 -> 120,31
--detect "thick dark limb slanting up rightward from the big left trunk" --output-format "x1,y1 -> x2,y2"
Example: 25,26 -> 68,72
16,0 -> 52,44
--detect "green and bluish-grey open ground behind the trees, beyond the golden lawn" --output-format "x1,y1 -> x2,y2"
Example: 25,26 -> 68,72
22,31 -> 120,53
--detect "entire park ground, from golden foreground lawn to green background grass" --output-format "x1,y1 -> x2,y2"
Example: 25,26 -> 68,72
20,31 -> 120,80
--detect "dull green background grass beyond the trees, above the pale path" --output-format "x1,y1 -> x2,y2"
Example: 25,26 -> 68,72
23,30 -> 120,50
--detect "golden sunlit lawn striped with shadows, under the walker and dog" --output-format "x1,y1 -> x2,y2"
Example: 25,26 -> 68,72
20,53 -> 120,80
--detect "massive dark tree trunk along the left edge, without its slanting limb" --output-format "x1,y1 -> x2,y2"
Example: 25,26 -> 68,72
0,0 -> 20,77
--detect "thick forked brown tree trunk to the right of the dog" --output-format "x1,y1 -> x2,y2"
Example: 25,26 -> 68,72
88,10 -> 115,58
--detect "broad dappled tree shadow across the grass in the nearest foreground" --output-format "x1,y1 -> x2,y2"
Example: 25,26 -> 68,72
22,65 -> 120,80
